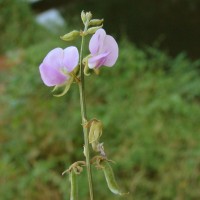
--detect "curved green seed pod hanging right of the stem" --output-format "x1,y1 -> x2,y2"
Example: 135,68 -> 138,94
100,160 -> 127,195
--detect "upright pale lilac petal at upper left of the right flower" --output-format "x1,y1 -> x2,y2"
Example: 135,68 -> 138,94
89,28 -> 106,54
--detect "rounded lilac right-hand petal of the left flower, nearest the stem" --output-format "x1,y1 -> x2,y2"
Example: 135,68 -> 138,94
62,46 -> 79,72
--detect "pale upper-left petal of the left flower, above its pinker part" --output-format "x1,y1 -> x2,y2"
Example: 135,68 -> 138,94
43,48 -> 63,69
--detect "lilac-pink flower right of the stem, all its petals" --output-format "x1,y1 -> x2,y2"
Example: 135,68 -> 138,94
88,28 -> 119,69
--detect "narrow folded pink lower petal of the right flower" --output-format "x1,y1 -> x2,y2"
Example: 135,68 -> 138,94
88,52 -> 109,69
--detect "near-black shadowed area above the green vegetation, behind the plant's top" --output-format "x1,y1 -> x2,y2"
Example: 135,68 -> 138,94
61,0 -> 200,58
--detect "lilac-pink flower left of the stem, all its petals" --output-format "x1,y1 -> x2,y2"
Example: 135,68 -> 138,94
39,46 -> 79,87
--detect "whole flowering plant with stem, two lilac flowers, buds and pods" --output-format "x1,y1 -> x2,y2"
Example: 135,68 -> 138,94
39,11 -> 124,200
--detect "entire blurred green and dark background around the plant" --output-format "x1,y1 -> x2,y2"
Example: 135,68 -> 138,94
0,0 -> 200,200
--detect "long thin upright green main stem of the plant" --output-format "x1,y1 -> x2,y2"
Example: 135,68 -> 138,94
79,26 -> 94,200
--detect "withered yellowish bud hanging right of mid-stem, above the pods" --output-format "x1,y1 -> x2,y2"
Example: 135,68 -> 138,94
89,119 -> 103,143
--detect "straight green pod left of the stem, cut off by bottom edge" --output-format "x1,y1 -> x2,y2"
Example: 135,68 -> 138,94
69,170 -> 78,200
